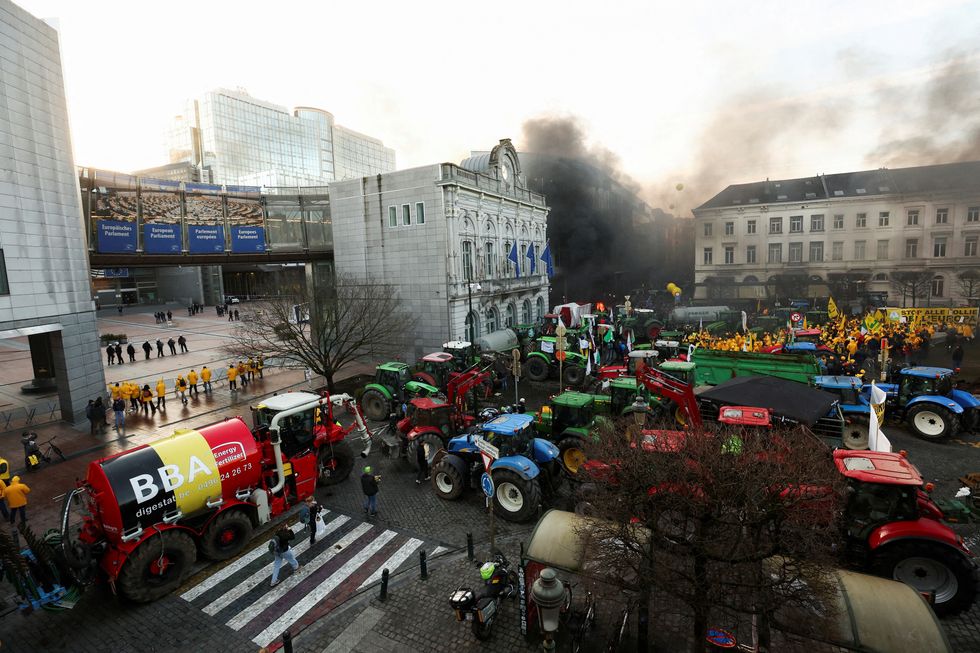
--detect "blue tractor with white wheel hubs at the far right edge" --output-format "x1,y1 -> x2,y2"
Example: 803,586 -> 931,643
864,367 -> 980,441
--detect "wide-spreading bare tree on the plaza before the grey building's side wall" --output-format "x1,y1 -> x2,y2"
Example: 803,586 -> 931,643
226,274 -> 416,392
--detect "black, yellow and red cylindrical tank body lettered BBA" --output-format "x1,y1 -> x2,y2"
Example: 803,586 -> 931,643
88,419 -> 261,534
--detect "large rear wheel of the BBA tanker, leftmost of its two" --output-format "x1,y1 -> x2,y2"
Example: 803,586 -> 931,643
118,528 -> 197,603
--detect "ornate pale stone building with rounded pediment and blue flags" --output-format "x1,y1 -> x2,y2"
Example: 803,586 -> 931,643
330,138 -> 550,357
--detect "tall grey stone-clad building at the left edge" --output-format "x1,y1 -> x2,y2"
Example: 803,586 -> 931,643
0,0 -> 105,421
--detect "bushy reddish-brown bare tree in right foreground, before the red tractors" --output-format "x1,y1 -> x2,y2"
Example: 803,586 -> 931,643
582,420 -> 843,651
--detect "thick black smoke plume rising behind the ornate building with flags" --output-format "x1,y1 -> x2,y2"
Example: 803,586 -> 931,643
521,117 -> 694,304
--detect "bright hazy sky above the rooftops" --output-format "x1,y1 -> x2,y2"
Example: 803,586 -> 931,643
15,0 -> 980,208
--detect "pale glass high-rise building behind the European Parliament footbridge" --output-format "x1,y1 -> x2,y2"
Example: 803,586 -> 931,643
167,89 -> 395,187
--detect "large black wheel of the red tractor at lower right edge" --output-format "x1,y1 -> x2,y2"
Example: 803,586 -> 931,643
872,541 -> 978,617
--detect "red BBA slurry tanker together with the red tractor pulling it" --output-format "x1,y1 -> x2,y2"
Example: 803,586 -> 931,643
61,392 -> 371,602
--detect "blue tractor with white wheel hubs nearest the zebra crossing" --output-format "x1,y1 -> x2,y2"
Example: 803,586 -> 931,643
432,414 -> 562,522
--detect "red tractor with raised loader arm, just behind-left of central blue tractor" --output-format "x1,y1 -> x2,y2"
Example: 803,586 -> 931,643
398,368 -> 490,465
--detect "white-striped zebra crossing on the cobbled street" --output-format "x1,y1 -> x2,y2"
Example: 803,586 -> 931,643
180,511 -> 446,646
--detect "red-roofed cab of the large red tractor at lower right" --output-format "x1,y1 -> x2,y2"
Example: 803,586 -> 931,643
834,449 -> 924,541
